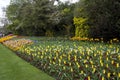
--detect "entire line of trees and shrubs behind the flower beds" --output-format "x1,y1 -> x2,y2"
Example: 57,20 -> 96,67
6,0 -> 120,40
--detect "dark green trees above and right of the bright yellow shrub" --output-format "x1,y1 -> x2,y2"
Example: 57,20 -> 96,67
74,0 -> 120,40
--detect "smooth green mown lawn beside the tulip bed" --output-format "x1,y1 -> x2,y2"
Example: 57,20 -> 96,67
0,44 -> 54,80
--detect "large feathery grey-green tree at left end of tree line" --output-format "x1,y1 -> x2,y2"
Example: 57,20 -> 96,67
7,0 -> 57,35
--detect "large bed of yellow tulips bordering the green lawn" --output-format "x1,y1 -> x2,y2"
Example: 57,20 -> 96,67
2,38 -> 120,80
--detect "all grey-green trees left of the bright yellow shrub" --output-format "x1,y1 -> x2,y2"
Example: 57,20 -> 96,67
6,0 -> 75,36
